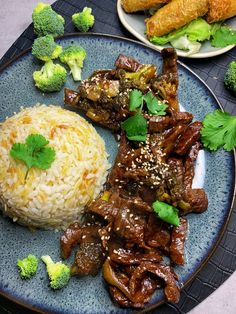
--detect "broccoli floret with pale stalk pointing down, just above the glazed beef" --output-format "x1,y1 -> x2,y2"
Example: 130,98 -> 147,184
59,45 -> 87,81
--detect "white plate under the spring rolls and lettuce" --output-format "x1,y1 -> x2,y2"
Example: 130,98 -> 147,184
117,0 -> 236,58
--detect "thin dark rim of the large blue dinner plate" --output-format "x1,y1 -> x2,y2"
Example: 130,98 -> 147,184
0,31 -> 236,314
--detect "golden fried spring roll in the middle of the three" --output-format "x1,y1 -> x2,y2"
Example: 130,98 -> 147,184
145,0 -> 208,38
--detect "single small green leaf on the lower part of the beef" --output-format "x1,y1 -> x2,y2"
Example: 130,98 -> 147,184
152,201 -> 180,227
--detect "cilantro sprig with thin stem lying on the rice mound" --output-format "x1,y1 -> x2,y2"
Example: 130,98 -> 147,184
10,134 -> 56,180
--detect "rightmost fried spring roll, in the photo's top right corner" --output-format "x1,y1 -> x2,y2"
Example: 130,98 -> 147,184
206,0 -> 236,23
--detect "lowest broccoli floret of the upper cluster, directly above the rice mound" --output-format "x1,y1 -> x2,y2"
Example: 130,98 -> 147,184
33,60 -> 67,92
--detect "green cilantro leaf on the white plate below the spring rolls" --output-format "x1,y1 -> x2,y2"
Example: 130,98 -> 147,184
211,26 -> 236,48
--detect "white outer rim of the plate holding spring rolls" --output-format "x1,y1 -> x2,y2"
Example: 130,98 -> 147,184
116,0 -> 236,59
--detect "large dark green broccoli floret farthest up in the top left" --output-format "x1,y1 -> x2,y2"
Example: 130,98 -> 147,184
32,2 -> 65,37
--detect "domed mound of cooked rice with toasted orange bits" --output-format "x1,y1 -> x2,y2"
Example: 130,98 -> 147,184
0,104 -> 109,229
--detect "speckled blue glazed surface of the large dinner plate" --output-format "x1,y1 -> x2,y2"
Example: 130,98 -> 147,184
0,34 -> 235,314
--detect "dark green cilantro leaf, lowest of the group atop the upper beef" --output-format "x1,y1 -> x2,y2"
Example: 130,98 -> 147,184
121,112 -> 147,141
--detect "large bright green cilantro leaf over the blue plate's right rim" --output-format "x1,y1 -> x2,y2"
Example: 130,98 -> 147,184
201,109 -> 236,151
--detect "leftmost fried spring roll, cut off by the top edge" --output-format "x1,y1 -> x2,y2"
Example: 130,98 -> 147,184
121,0 -> 171,13
